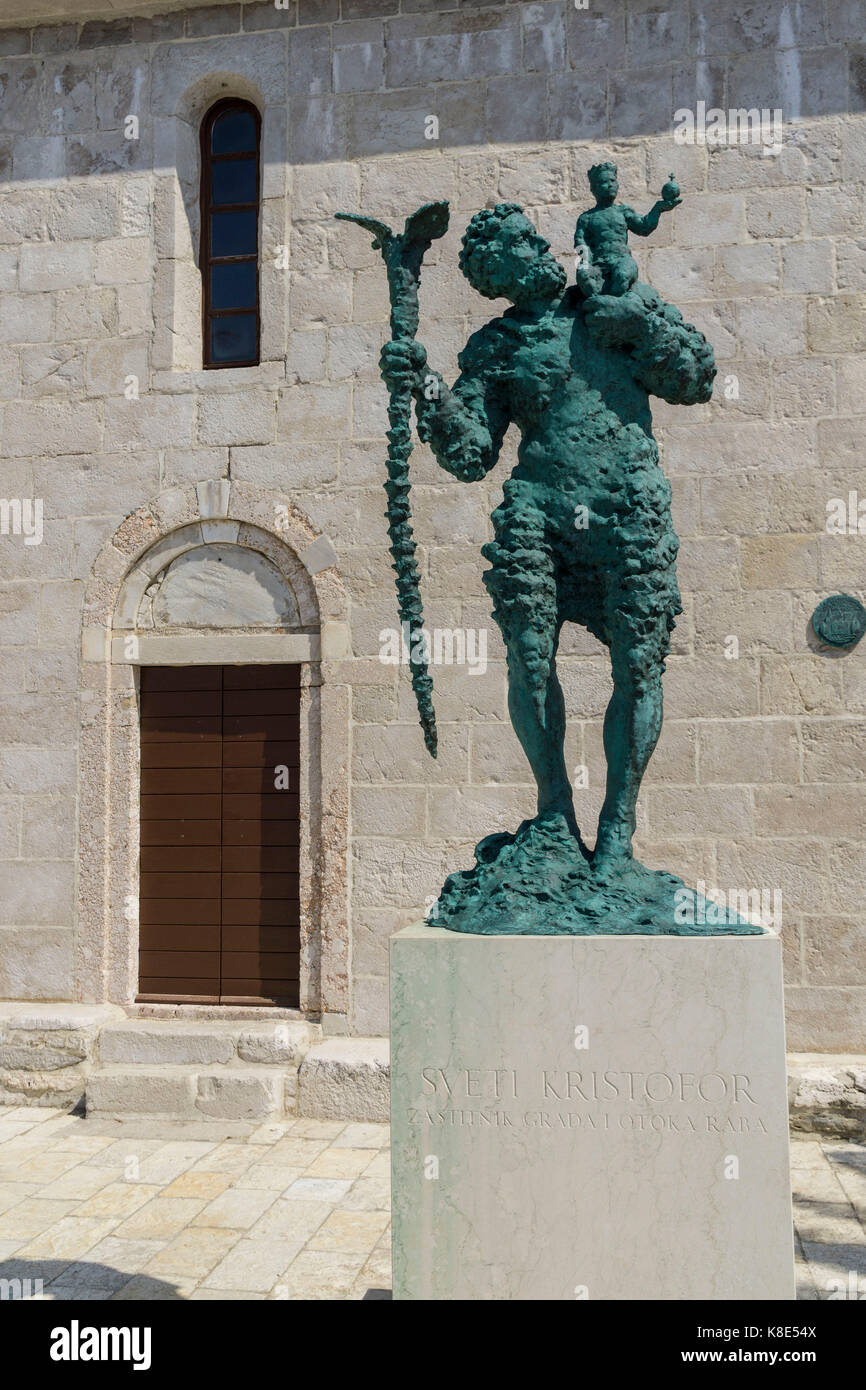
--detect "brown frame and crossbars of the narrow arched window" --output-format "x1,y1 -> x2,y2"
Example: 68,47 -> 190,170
199,96 -> 261,371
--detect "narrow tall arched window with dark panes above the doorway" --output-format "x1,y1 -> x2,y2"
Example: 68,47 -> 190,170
202,99 -> 261,367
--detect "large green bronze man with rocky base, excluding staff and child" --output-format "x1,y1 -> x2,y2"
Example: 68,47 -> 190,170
339,179 -> 760,935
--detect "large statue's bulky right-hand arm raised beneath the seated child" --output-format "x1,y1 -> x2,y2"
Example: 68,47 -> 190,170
584,286 -> 716,406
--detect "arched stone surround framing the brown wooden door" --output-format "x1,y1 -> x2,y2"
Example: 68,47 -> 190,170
75,480 -> 350,1033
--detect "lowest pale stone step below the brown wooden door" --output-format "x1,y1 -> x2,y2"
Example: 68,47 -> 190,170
85,1063 -> 297,1122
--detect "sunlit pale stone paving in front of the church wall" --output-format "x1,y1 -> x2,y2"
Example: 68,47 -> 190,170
0,1108 -> 866,1300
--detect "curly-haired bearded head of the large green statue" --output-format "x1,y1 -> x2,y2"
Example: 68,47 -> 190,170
460,203 -> 566,304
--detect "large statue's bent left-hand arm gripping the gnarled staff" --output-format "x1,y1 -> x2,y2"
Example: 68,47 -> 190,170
381,333 -> 509,482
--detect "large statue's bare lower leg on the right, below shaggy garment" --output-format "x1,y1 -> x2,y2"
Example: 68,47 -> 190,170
594,648 -> 662,870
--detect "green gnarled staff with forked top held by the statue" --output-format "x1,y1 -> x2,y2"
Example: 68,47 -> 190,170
336,203 -> 448,758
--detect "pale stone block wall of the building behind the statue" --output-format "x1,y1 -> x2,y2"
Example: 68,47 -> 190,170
0,0 -> 866,1051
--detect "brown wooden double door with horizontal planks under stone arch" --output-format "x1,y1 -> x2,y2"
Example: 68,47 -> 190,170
138,666 -> 300,1006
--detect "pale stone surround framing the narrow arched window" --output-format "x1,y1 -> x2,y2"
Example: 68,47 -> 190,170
153,47 -> 289,374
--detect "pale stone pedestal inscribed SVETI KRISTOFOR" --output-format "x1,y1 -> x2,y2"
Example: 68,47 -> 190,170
391,924 -> 794,1300
